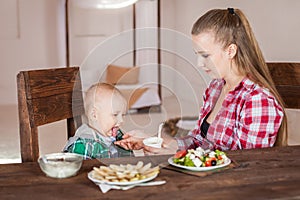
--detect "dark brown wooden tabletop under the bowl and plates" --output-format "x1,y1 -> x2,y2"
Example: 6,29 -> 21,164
0,146 -> 300,200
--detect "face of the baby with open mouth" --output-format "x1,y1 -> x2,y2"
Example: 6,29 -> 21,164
96,93 -> 127,137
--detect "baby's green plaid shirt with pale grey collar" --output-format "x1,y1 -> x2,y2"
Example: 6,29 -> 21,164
64,124 -> 134,159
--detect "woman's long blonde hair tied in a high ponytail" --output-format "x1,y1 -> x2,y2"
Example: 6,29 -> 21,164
191,8 -> 287,146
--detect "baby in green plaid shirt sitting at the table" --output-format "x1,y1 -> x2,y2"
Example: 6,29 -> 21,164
64,83 -> 134,159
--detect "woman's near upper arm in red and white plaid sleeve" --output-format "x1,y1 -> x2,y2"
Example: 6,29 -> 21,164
237,92 -> 283,149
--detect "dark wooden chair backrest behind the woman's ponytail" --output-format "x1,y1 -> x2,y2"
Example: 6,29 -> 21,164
267,62 -> 300,109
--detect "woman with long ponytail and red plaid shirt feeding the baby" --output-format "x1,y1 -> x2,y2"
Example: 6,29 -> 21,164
115,8 -> 286,150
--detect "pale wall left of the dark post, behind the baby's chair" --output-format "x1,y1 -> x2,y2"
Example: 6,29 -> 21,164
0,0 -> 65,104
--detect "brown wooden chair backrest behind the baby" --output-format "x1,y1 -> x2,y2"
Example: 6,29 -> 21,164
17,67 -> 84,162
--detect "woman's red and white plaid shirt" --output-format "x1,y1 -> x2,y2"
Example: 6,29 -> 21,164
176,78 -> 283,150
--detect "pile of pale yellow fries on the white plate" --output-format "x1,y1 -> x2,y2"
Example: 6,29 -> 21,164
92,161 -> 159,182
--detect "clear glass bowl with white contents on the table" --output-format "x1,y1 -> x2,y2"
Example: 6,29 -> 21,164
38,153 -> 83,178
